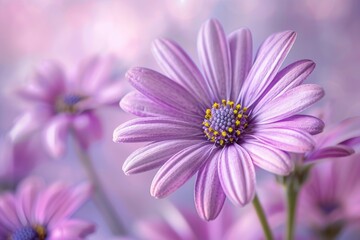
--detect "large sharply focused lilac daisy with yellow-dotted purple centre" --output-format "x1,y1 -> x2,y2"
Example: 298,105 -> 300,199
113,20 -> 324,220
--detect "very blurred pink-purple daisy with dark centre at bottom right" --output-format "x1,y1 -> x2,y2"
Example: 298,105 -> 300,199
298,153 -> 360,239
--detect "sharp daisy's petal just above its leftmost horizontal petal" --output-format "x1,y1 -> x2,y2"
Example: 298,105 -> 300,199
120,91 -> 202,122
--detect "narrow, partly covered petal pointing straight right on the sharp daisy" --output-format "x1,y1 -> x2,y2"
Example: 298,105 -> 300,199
257,115 -> 325,135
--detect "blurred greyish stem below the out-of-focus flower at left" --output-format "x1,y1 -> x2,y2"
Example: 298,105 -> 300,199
74,136 -> 126,235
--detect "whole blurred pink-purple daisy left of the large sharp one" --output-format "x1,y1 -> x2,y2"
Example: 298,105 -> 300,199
10,57 -> 123,157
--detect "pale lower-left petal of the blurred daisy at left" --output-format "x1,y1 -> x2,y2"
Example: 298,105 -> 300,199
9,106 -> 53,141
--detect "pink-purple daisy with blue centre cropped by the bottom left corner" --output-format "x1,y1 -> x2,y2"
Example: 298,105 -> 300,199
0,178 -> 95,240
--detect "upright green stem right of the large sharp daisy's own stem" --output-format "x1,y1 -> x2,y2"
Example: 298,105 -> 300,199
286,176 -> 299,240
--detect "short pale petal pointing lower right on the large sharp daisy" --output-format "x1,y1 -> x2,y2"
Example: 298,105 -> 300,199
242,141 -> 294,175
